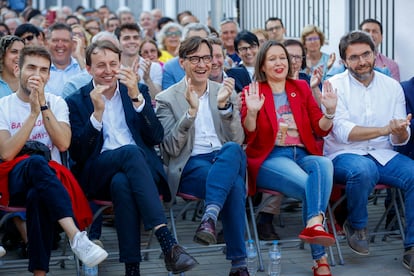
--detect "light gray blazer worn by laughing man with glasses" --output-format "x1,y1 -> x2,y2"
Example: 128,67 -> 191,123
155,78 -> 244,202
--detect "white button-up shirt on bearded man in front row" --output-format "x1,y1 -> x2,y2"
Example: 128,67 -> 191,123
324,70 -> 410,165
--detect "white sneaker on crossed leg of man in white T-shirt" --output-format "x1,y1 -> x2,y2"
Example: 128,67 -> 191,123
70,231 -> 108,267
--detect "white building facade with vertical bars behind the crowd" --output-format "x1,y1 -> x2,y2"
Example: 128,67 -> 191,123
33,0 -> 414,80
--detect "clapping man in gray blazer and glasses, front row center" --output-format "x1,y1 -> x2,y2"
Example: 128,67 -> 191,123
155,37 -> 248,275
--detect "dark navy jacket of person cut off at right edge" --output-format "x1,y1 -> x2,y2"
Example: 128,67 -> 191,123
396,77 -> 414,159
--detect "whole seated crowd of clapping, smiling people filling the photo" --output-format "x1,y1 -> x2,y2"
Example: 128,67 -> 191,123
0,2 -> 414,276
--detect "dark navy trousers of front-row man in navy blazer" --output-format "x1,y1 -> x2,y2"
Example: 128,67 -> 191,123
89,145 -> 167,263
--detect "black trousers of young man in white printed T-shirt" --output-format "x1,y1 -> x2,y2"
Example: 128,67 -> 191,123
9,155 -> 73,272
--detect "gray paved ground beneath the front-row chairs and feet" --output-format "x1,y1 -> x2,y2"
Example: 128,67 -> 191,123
0,195 -> 409,276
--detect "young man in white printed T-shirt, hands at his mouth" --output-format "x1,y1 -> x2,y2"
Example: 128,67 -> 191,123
0,46 -> 108,276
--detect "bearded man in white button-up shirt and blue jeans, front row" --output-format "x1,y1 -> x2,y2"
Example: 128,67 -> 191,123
324,31 -> 414,273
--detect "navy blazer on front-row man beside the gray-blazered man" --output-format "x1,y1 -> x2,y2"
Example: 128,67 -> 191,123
66,81 -> 171,202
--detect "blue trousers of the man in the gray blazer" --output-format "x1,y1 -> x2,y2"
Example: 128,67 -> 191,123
180,142 -> 246,260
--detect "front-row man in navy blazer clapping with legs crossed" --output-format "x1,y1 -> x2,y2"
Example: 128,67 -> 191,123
66,41 -> 197,276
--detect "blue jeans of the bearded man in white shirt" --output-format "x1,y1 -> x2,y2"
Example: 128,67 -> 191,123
333,153 -> 414,248
